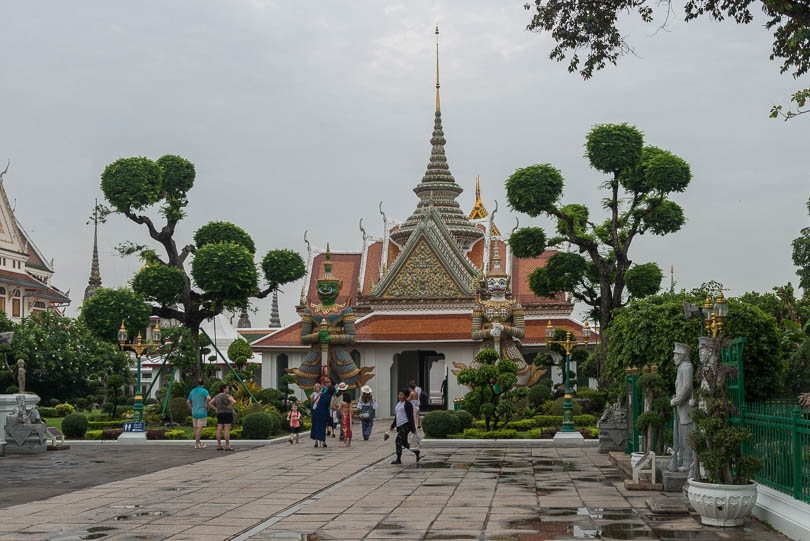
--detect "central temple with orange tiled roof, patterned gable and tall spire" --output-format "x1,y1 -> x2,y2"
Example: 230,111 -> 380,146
252,31 -> 582,416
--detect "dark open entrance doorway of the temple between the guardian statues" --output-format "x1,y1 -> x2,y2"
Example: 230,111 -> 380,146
390,349 -> 447,414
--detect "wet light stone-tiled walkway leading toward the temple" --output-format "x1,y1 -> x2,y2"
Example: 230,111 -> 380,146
0,427 -> 786,541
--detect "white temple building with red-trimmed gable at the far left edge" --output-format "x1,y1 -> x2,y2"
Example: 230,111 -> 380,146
0,162 -> 70,322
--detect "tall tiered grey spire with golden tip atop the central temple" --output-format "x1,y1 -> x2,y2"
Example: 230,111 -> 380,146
391,27 -> 484,248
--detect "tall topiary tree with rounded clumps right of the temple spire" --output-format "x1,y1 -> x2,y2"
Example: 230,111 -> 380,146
506,124 -> 692,378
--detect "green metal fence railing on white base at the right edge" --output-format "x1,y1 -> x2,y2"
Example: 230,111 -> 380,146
740,402 -> 810,502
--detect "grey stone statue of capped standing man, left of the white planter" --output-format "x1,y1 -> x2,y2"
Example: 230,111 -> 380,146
669,342 -> 695,472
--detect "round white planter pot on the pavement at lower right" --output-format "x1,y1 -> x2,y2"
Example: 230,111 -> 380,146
686,479 -> 757,527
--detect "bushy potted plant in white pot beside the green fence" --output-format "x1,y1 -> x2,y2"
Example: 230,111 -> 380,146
687,337 -> 761,526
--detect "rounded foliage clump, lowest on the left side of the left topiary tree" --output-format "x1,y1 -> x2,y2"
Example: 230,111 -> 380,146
80,287 -> 151,343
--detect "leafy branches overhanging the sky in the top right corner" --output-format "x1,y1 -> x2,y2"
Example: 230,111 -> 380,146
524,0 -> 810,120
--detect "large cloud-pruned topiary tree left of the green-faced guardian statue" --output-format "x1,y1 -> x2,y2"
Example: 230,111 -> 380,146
98,155 -> 305,377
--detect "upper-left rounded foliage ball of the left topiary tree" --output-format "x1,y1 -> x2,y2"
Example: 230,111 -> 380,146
101,158 -> 163,213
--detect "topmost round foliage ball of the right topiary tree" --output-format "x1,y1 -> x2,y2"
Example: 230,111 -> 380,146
585,124 -> 644,173
